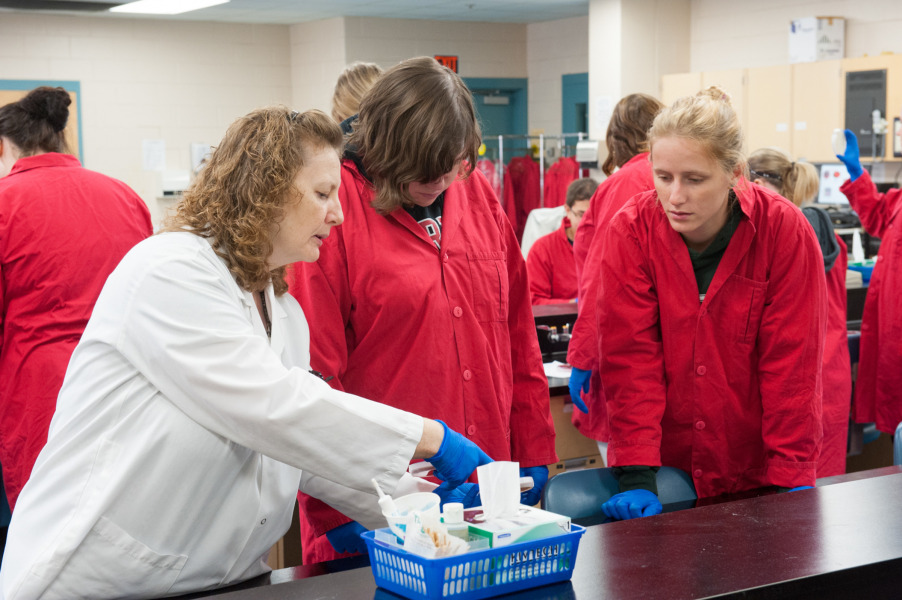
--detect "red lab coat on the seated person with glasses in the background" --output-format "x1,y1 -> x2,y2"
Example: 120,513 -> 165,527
526,217 -> 577,305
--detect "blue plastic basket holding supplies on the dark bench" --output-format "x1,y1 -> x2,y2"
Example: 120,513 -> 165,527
362,525 -> 586,600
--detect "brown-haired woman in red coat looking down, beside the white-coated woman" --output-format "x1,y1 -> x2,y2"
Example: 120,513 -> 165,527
290,57 -> 556,563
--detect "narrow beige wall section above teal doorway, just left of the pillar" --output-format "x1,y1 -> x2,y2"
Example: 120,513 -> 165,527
526,17 -> 589,135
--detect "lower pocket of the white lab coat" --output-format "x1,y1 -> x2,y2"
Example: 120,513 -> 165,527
43,517 -> 188,600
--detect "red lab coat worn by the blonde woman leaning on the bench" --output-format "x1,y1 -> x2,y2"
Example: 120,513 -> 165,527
598,183 -> 826,497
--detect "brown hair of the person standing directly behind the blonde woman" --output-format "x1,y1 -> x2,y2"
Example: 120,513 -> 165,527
601,94 -> 664,175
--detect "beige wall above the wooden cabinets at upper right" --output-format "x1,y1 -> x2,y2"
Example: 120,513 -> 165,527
689,0 -> 902,71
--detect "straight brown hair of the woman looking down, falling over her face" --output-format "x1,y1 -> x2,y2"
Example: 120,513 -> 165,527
348,56 -> 482,214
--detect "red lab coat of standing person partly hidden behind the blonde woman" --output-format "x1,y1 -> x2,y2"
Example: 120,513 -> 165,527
567,152 -> 655,442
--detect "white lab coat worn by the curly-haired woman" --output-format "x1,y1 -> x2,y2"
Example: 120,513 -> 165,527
0,233 -> 423,600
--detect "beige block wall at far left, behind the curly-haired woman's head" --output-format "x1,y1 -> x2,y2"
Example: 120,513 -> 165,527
0,13 -> 291,223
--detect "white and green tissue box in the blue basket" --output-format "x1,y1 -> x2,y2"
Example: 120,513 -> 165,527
464,504 -> 570,548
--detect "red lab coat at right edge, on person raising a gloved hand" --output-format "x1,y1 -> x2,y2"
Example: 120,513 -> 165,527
839,171 -> 902,434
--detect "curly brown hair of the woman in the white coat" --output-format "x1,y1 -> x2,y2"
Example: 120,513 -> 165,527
163,106 -> 342,295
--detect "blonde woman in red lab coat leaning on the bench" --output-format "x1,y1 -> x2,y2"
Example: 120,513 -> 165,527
597,87 -> 826,519
